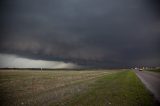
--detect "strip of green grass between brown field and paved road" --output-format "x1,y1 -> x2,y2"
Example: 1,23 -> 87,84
51,71 -> 156,106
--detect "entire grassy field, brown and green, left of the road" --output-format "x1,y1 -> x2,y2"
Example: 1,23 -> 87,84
0,70 -> 158,106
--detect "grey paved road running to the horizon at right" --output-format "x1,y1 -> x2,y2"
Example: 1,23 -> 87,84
135,70 -> 160,102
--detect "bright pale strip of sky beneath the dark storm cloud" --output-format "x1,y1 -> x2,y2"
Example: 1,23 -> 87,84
0,54 -> 80,69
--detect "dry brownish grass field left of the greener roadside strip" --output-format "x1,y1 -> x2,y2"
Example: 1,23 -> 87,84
0,70 -> 116,106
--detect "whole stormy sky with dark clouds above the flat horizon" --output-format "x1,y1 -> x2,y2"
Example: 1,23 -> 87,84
0,0 -> 160,68
